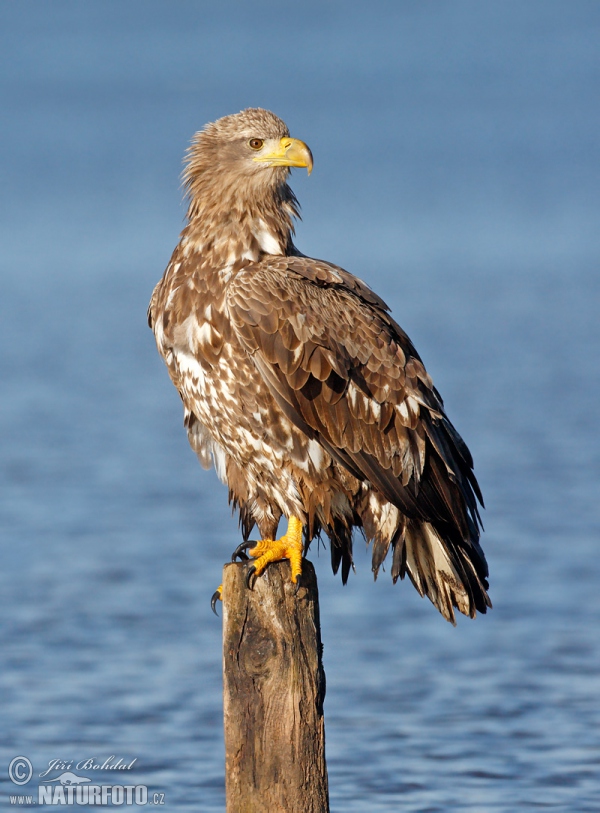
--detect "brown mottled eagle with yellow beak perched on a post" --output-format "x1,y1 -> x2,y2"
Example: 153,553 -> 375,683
148,108 -> 492,624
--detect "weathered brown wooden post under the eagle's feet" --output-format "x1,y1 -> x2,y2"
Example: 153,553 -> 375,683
223,561 -> 329,813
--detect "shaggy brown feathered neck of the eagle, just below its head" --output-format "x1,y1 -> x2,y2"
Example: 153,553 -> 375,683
181,176 -> 299,270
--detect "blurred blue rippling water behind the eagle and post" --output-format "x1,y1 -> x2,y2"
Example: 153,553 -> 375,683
0,0 -> 600,813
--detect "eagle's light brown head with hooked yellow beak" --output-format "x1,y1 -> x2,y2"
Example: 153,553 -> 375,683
183,108 -> 313,230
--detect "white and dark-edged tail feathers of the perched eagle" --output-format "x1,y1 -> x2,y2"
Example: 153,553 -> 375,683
392,521 -> 492,625
